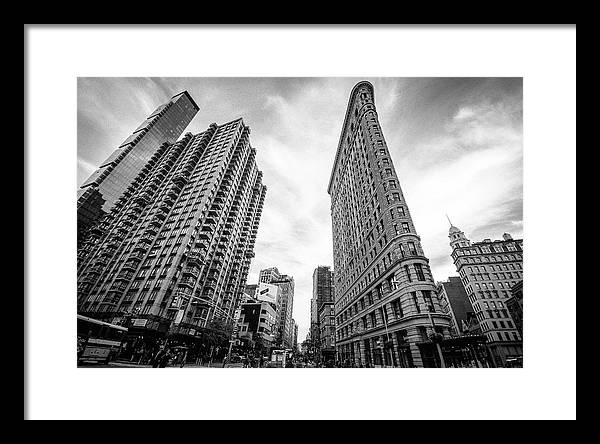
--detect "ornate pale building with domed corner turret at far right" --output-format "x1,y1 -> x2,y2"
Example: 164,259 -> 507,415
448,224 -> 523,367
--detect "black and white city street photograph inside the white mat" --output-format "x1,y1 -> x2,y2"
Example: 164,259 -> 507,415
77,78 -> 523,368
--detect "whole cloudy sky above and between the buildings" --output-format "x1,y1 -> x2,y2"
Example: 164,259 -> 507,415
77,77 -> 523,341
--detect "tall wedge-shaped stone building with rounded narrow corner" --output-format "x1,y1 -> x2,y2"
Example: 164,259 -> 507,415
328,82 -> 450,367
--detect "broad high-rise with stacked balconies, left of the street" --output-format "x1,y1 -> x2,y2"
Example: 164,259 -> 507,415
78,119 -> 266,344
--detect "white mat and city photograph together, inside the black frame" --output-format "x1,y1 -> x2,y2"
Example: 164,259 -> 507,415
25,25 -> 576,419
